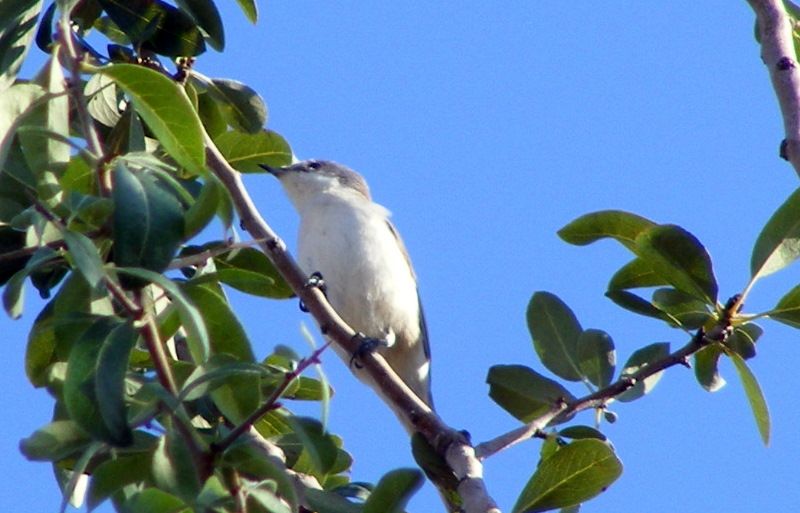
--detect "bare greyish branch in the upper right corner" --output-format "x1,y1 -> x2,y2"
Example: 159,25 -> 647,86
747,0 -> 800,175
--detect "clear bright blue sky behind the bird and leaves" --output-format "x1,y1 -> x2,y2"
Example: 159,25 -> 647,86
0,0 -> 800,513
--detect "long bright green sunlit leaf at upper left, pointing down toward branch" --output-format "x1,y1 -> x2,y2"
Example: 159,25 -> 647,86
101,64 -> 205,175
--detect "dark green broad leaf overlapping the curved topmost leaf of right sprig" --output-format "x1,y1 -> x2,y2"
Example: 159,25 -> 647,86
636,225 -> 717,305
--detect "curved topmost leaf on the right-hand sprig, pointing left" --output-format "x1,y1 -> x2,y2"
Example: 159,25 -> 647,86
558,210 -> 656,251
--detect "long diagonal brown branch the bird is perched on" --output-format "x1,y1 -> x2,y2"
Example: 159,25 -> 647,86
205,134 -> 500,513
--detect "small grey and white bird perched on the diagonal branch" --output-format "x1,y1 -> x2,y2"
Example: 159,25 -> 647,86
262,160 -> 433,419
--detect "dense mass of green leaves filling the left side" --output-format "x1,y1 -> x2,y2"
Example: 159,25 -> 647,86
0,4 -> 421,512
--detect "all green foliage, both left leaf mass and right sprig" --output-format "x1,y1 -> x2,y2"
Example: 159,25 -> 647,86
0,0 -> 800,512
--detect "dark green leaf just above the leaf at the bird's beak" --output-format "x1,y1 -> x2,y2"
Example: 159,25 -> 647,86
203,78 -> 267,134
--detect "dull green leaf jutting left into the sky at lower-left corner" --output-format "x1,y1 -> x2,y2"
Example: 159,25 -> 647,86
20,420 -> 91,462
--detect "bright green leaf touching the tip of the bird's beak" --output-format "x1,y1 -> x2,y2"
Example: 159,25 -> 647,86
214,130 -> 292,173
